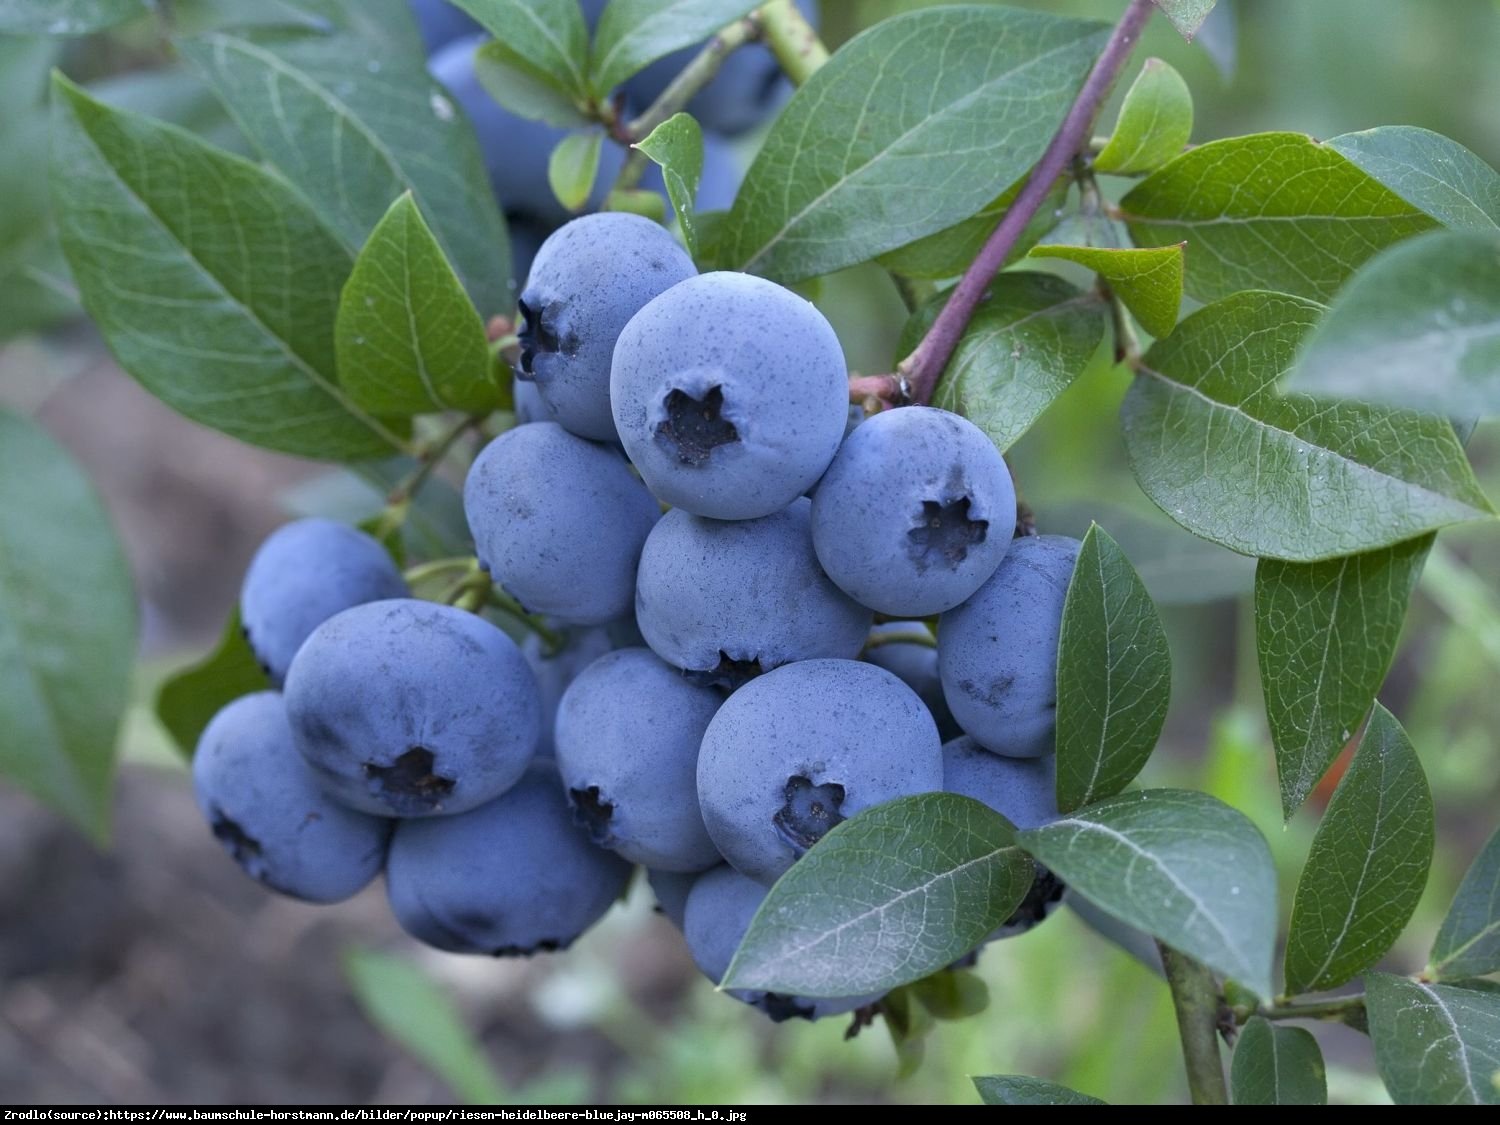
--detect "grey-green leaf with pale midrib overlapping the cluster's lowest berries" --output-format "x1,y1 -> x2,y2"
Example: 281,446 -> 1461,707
722,794 -> 1035,996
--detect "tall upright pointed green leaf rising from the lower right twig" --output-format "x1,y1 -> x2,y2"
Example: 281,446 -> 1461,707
1284,704 -> 1433,996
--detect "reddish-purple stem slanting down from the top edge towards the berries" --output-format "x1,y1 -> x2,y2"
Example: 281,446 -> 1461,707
896,0 -> 1152,404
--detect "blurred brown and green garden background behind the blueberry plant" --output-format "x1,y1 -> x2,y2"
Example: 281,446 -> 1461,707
0,0 -> 1500,1103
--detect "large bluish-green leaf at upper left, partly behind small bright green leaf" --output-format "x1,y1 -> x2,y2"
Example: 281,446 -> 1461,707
180,33 -> 512,315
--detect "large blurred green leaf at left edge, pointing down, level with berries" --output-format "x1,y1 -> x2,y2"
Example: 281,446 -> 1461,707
0,411 -> 135,840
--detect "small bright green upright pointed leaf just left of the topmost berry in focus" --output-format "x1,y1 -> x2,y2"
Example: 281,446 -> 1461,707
336,195 -> 501,416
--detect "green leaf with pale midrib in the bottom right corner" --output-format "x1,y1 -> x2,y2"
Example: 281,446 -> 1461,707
1365,972 -> 1500,1106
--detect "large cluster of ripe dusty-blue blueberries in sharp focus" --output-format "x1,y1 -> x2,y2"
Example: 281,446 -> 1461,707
195,215 -> 1079,1019
